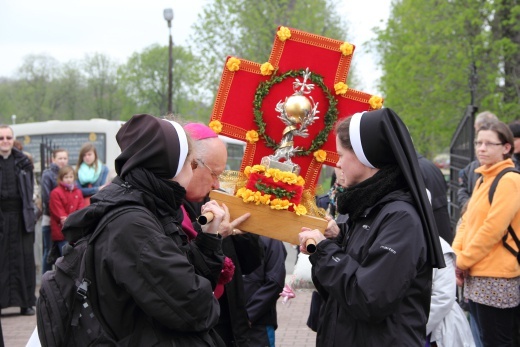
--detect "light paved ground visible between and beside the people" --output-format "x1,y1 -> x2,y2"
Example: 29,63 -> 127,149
0,246 -> 316,347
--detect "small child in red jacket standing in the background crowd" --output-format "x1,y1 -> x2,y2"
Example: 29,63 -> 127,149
49,165 -> 84,255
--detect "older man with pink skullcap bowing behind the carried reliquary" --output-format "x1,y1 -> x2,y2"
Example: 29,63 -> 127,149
183,123 -> 263,347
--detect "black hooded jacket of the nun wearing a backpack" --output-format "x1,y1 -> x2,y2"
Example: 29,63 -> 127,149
62,177 -> 224,347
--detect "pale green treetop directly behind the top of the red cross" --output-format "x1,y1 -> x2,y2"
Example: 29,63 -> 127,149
191,0 -> 354,96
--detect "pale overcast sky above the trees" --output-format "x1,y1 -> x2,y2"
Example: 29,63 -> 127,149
0,0 -> 390,93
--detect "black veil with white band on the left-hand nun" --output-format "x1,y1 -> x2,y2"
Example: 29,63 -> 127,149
115,114 -> 188,179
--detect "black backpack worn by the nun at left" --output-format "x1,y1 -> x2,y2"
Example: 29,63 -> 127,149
36,205 -> 155,347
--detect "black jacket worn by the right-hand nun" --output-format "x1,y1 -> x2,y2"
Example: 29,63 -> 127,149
309,190 -> 432,347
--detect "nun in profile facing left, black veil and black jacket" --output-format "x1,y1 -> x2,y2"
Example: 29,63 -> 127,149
300,108 -> 444,347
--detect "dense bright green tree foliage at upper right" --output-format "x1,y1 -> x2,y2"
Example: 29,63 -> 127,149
375,0 -> 520,157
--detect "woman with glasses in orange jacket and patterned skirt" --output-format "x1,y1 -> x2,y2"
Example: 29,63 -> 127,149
453,121 -> 520,347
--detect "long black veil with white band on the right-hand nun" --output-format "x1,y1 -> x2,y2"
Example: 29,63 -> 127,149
349,108 -> 445,268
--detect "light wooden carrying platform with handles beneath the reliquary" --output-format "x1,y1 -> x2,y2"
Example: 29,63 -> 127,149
209,190 -> 328,245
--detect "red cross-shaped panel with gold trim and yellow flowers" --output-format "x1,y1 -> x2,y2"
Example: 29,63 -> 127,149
210,26 -> 383,189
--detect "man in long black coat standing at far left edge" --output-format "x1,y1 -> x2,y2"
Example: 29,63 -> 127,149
0,125 -> 36,315
